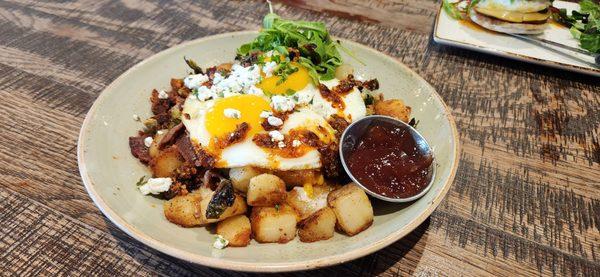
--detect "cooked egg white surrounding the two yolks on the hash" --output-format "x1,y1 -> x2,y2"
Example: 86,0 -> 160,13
182,73 -> 367,170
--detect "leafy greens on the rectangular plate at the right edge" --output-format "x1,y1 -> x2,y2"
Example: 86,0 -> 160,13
552,0 -> 600,53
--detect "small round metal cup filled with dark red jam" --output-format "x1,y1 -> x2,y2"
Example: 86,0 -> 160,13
340,115 -> 436,202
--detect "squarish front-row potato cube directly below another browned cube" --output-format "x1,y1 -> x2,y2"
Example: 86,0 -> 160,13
250,204 -> 297,243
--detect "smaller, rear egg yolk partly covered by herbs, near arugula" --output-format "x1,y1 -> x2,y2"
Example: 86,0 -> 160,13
257,63 -> 310,94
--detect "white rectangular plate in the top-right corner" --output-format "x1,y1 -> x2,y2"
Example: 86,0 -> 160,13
433,1 -> 600,76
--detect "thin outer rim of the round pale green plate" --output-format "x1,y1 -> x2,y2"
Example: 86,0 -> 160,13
77,31 -> 460,272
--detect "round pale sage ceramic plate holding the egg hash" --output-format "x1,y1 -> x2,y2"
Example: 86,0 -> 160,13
78,32 -> 459,272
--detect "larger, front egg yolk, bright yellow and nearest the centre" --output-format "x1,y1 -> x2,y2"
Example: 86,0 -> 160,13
204,94 -> 271,137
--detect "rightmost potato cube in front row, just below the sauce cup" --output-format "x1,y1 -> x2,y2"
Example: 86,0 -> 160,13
327,183 -> 373,236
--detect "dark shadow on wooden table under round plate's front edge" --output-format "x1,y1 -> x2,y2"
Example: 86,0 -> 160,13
104,215 -> 430,277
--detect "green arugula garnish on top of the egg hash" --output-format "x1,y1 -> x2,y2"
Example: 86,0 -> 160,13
237,12 -> 345,83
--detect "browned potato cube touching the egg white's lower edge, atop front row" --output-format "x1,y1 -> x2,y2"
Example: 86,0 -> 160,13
246,174 -> 287,207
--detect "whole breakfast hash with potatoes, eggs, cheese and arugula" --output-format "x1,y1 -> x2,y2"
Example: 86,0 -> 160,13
129,13 -> 414,248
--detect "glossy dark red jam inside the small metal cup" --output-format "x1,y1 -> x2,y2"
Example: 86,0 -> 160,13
346,122 -> 433,198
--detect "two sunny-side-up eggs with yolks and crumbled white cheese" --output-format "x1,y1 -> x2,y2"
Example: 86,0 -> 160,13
182,61 -> 366,170
